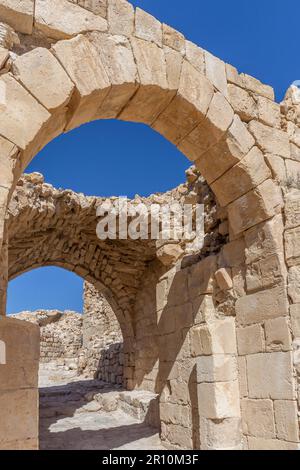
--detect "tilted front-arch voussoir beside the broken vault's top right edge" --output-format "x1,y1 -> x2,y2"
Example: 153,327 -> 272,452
211,147 -> 271,206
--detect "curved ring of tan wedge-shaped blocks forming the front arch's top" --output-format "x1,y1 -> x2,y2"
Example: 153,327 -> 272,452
0,0 -> 278,255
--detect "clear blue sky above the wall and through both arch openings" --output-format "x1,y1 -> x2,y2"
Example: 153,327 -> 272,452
8,0 -> 300,312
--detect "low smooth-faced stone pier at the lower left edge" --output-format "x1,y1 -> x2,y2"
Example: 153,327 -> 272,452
0,317 -> 39,450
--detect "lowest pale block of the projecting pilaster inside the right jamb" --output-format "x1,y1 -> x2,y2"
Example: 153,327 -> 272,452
200,417 -> 242,450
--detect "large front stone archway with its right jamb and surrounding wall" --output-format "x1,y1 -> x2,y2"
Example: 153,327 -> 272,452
0,0 -> 300,448
